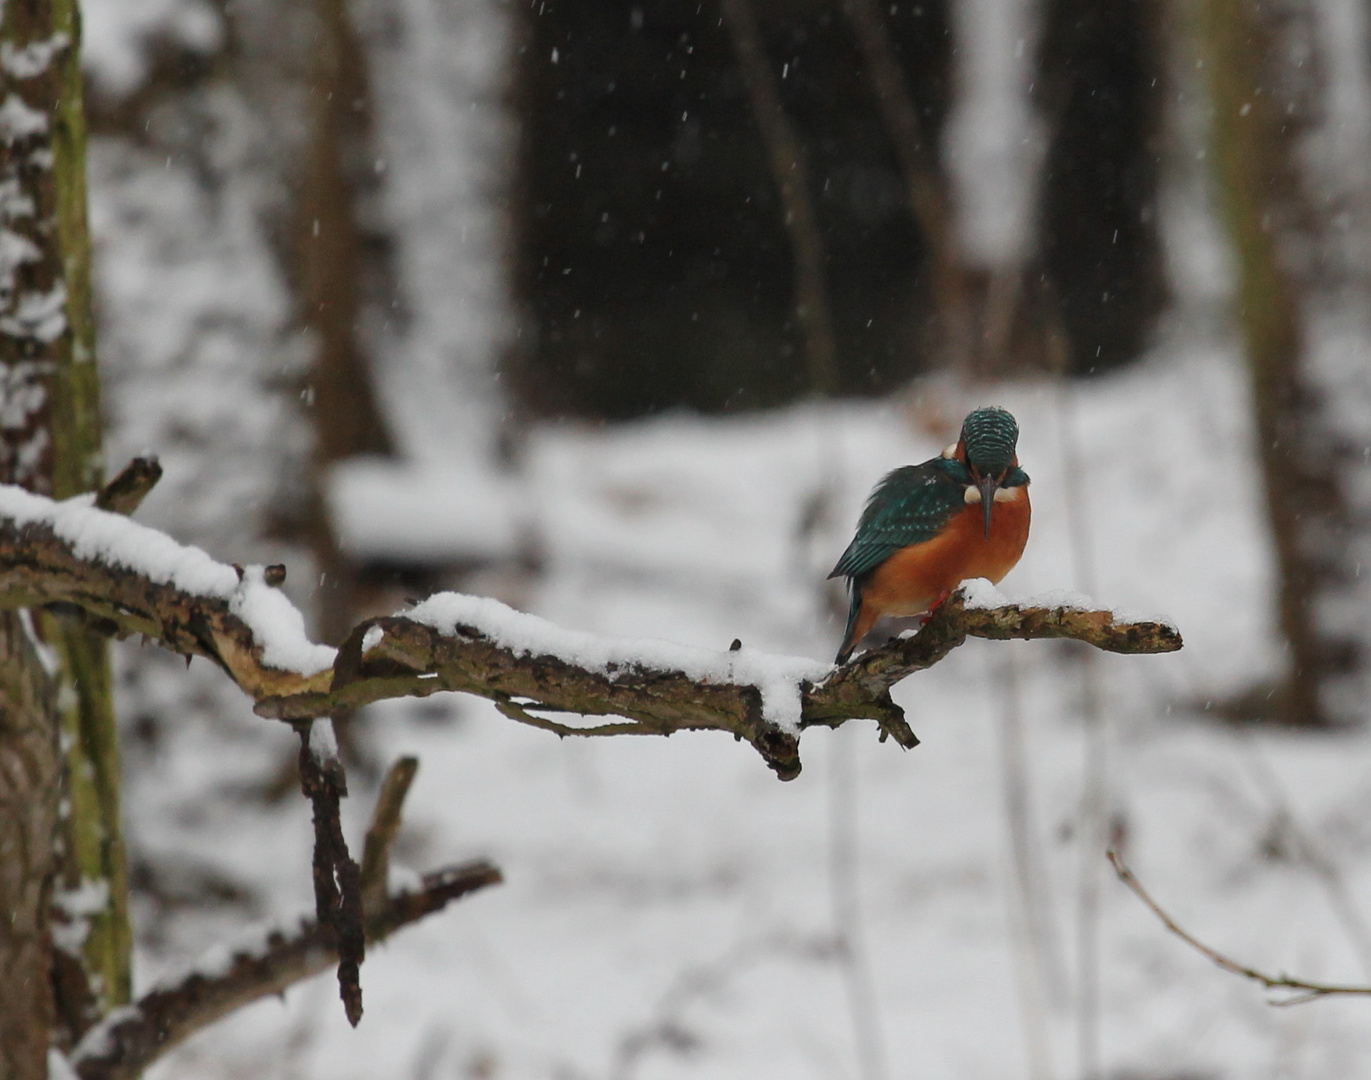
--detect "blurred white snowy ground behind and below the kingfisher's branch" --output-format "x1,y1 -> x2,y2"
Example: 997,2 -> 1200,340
115,339 -> 1371,1080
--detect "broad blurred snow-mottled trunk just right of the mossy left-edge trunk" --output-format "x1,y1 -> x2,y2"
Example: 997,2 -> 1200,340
90,0 -> 317,581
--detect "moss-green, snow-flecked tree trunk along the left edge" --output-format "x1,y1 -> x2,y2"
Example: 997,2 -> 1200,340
0,0 -> 130,1077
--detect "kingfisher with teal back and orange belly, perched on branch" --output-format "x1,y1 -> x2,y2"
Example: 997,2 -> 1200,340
829,406 -> 1030,663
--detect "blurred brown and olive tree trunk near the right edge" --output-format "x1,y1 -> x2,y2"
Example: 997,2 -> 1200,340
1196,0 -> 1367,725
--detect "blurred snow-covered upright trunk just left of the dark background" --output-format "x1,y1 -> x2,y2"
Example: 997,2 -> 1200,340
363,0 -> 515,469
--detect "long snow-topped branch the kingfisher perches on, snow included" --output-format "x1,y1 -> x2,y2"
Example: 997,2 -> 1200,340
0,487 -> 1182,780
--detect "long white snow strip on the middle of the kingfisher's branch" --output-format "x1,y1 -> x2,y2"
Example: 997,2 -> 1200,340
403,592 -> 832,733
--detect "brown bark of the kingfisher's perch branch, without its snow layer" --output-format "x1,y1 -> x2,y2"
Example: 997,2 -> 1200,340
0,488 -> 1182,780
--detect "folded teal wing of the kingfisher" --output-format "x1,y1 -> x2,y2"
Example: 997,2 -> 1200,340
829,458 -> 971,578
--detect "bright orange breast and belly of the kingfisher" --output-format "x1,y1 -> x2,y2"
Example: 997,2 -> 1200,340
862,487 -> 1031,619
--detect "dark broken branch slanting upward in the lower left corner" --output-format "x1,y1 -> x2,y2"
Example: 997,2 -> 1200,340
70,861 -> 502,1080
